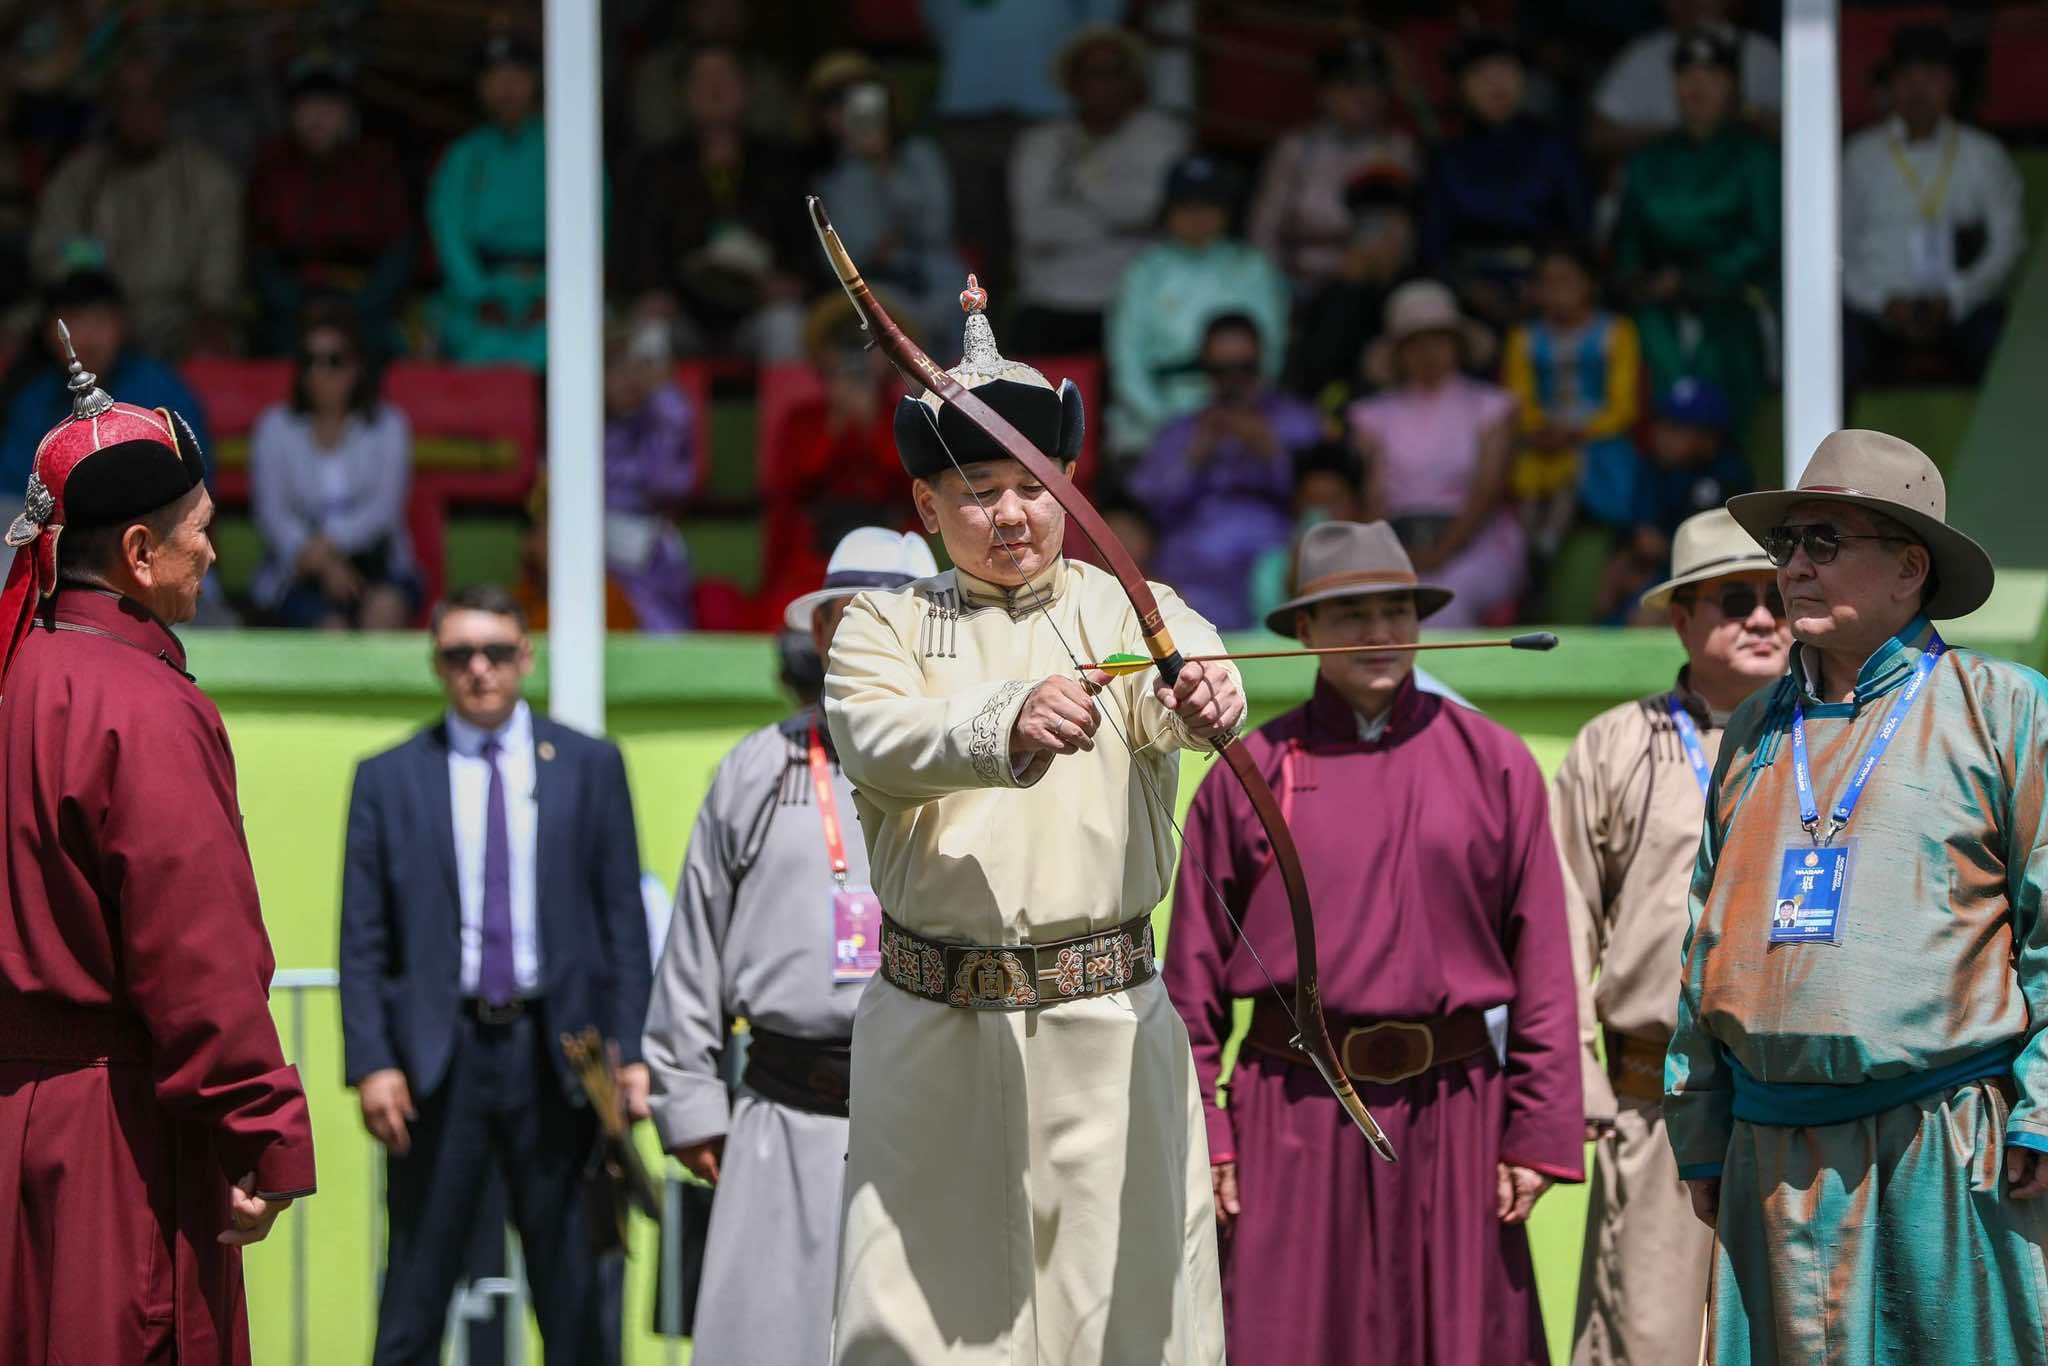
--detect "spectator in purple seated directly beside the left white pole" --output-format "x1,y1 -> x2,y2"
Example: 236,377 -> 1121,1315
604,322 -> 698,635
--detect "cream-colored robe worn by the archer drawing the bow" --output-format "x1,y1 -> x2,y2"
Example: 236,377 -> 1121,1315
825,561 -> 1223,1366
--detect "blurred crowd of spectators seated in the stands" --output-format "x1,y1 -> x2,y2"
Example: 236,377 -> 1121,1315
0,0 -> 2025,631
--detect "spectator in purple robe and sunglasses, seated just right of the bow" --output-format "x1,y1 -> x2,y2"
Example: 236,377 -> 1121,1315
1128,313 -> 1321,631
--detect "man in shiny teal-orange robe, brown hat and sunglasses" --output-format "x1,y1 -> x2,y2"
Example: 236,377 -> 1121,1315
1665,432 -> 2048,1366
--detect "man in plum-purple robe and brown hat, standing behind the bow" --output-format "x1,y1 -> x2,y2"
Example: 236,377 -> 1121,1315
1165,522 -> 1583,1366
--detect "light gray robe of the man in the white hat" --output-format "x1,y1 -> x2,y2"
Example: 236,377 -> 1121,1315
643,713 -> 868,1366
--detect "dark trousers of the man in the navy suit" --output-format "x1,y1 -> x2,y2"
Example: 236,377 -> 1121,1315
375,1012 -> 618,1366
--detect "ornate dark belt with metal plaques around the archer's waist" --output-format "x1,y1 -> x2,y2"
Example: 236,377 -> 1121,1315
883,915 -> 1159,1010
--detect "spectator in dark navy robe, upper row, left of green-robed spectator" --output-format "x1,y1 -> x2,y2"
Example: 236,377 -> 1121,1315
1417,31 -> 1587,328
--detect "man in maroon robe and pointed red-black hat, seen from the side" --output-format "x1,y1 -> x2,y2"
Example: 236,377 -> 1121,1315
0,331 -> 313,1366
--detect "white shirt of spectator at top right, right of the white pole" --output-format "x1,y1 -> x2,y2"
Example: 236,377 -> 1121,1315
1841,117 -> 2025,322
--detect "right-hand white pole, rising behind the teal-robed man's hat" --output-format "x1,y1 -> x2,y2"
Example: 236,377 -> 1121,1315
1784,0 -> 1841,487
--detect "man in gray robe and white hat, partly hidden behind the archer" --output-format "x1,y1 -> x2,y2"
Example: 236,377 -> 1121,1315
643,526 -> 938,1366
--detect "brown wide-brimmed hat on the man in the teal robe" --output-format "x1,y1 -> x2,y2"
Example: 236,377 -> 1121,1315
1729,428 -> 1997,618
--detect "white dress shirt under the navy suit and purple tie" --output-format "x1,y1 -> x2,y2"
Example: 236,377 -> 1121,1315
449,702 -> 541,995
